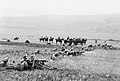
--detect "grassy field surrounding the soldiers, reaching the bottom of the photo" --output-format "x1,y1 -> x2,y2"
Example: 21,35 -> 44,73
0,42 -> 120,81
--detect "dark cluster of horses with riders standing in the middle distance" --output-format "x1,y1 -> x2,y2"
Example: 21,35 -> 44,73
39,36 -> 87,46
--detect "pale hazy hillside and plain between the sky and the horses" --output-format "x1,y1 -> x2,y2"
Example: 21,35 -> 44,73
0,14 -> 120,39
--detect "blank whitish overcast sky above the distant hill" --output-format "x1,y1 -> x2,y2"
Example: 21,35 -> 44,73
0,0 -> 120,16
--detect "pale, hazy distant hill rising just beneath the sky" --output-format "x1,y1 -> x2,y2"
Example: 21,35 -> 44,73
0,14 -> 120,38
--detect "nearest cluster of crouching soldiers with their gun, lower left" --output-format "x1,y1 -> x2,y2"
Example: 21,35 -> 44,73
0,54 -> 51,71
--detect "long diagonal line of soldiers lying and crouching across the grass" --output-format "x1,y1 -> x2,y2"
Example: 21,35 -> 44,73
0,44 -> 113,70
